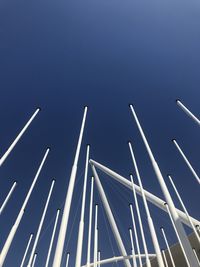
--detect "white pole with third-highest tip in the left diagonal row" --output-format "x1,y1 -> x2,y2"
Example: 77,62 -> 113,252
27,180 -> 55,267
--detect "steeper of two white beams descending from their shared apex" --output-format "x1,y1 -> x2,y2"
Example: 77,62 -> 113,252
91,165 -> 131,267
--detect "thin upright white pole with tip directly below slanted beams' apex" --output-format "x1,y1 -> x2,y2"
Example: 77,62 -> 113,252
87,177 -> 94,267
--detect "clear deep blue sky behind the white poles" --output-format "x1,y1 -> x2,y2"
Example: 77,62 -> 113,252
0,0 -> 200,267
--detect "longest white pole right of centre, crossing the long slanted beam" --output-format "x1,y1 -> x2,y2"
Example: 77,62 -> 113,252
130,105 -> 198,267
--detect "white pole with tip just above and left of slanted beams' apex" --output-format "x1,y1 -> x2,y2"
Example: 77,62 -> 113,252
75,145 -> 90,267
